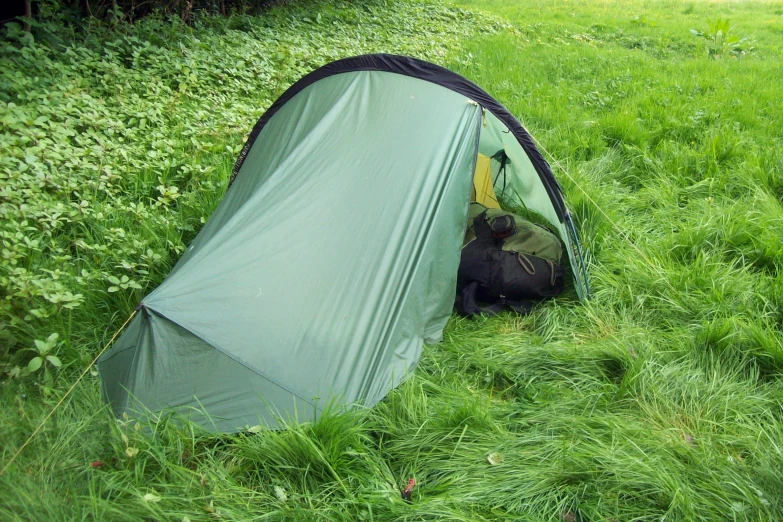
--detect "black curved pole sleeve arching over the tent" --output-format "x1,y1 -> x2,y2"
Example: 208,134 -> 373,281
228,54 -> 590,298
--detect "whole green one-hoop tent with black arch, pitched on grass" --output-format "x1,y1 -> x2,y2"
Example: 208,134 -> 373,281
99,55 -> 588,431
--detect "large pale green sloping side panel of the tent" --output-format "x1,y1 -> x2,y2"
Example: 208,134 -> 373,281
101,72 -> 481,429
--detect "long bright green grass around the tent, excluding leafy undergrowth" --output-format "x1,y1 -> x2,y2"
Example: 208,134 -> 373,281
0,0 -> 783,521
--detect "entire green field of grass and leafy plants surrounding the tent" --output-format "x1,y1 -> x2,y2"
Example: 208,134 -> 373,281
0,0 -> 783,522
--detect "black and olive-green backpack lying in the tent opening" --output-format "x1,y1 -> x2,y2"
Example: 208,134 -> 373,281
455,206 -> 564,316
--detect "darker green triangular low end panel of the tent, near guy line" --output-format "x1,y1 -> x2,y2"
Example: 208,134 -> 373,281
98,310 -> 306,431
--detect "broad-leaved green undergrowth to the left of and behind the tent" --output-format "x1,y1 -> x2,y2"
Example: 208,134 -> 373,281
0,2 -> 502,371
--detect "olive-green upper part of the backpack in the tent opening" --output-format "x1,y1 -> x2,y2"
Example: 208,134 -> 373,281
463,202 -> 563,264
